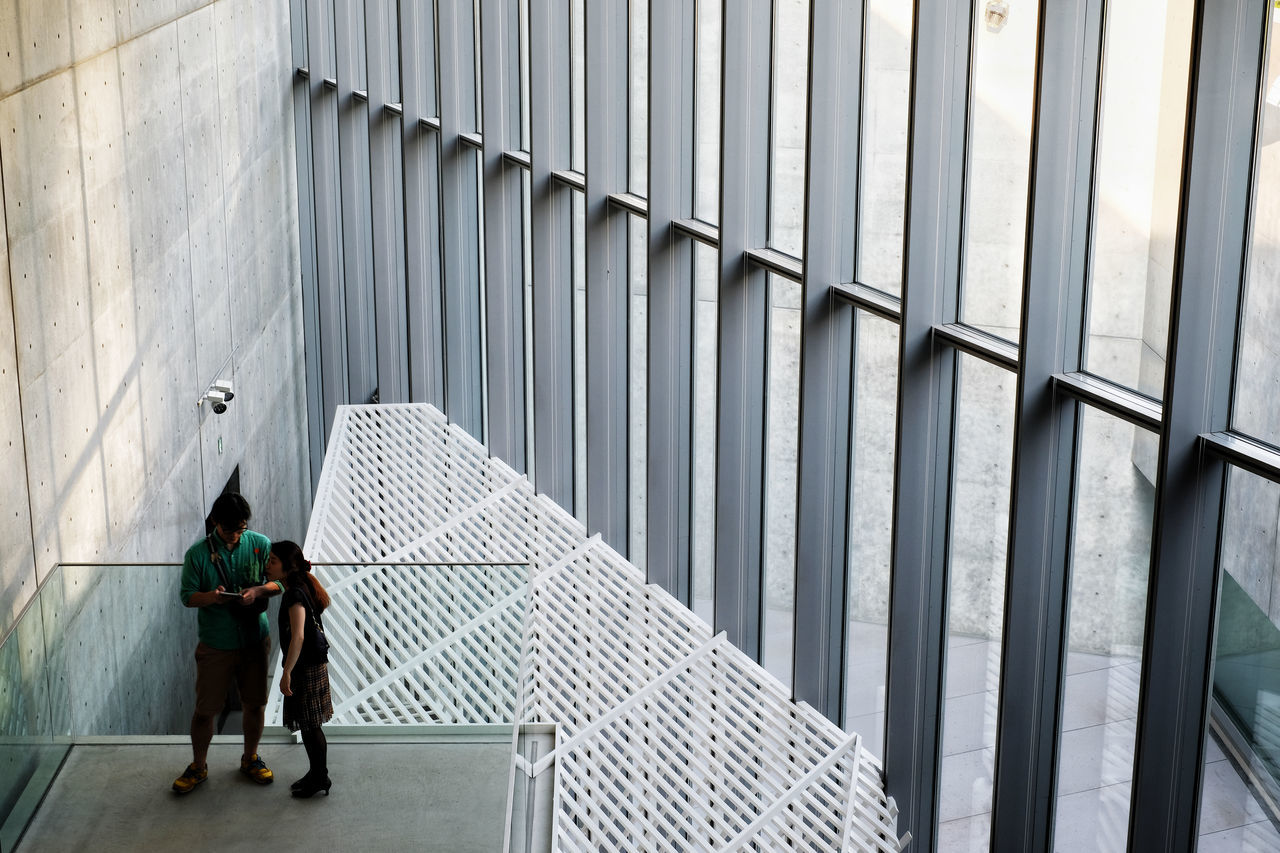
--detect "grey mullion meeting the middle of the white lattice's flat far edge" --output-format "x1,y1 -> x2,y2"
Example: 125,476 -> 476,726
365,3 -> 410,402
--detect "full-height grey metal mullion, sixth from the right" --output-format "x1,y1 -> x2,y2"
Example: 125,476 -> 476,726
645,0 -> 695,605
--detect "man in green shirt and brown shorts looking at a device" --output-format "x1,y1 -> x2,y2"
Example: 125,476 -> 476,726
173,492 -> 284,794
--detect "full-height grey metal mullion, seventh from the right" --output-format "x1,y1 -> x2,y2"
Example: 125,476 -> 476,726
584,0 -> 631,553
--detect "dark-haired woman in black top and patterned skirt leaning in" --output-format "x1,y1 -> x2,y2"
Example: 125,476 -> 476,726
266,540 -> 333,797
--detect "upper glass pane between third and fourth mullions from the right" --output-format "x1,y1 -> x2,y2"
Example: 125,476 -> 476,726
856,0 -> 913,293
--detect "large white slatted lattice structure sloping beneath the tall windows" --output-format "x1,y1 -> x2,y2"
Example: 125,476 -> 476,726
293,405 -> 902,852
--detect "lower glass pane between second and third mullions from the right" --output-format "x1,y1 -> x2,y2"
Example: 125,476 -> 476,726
938,355 -> 1018,850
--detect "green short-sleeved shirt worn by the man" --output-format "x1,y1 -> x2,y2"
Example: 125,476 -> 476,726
178,530 -> 271,649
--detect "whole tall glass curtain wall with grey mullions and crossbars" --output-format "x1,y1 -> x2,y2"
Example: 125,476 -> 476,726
294,0 -> 1280,849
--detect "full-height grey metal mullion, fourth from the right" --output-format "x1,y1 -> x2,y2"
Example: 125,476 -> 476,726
792,0 -> 863,725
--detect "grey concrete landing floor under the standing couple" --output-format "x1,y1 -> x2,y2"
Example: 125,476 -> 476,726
17,740 -> 511,853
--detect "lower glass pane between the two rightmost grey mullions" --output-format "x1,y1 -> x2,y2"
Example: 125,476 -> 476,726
1055,407 -> 1156,853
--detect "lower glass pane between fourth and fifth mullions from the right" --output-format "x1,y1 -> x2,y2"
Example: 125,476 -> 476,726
763,274 -> 800,684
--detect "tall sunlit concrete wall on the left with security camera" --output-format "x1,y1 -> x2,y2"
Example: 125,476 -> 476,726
0,0 -> 310,731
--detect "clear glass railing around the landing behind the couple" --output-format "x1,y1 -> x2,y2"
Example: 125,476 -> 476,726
0,562 -> 529,850
